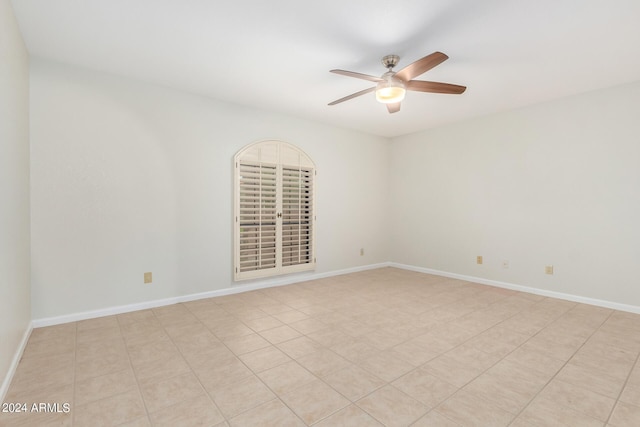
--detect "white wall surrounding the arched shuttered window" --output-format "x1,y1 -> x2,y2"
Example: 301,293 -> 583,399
31,59 -> 388,319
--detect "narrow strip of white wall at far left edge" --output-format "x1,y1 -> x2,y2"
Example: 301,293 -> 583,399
0,0 -> 31,401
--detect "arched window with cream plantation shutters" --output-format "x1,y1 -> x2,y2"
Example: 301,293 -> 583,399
234,141 -> 316,280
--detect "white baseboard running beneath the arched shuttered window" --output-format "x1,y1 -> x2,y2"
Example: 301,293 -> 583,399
32,262 -> 389,328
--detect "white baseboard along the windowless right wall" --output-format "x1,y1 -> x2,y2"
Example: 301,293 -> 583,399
388,262 -> 640,314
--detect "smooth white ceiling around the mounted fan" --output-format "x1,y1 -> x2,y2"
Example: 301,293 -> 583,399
13,0 -> 640,137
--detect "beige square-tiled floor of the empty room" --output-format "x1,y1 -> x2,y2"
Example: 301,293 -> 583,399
0,268 -> 640,427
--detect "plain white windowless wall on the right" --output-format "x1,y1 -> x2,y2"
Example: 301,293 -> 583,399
390,83 -> 640,306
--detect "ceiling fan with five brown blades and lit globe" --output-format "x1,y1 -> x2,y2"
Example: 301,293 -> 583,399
329,52 -> 467,113
